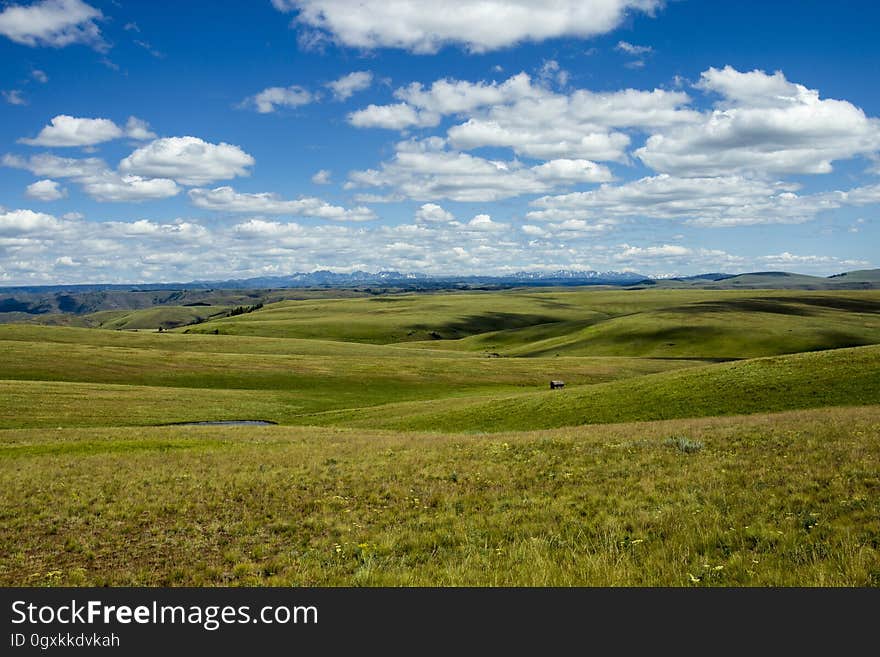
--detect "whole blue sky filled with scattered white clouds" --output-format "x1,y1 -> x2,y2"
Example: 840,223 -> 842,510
0,0 -> 880,285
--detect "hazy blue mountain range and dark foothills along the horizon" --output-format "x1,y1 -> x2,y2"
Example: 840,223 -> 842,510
0,269 -> 880,323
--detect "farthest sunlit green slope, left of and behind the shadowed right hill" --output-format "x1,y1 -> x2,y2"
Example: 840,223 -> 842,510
180,288 -> 848,344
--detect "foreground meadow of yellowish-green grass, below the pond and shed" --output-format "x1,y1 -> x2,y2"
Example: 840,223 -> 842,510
0,406 -> 880,586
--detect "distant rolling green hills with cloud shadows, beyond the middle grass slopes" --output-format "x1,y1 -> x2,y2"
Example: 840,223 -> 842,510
182,289 -> 880,359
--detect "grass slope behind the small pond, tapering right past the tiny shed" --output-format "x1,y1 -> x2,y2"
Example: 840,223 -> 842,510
0,327 -> 695,427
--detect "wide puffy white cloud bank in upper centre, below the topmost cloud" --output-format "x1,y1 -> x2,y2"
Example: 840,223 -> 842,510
348,73 -> 700,162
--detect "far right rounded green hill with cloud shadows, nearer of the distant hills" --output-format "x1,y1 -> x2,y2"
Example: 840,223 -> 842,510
402,290 -> 880,359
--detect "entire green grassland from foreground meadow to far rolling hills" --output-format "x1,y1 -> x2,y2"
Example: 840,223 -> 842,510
0,288 -> 880,586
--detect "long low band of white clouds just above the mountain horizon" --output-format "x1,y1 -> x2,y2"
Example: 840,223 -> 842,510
0,210 -> 876,284
